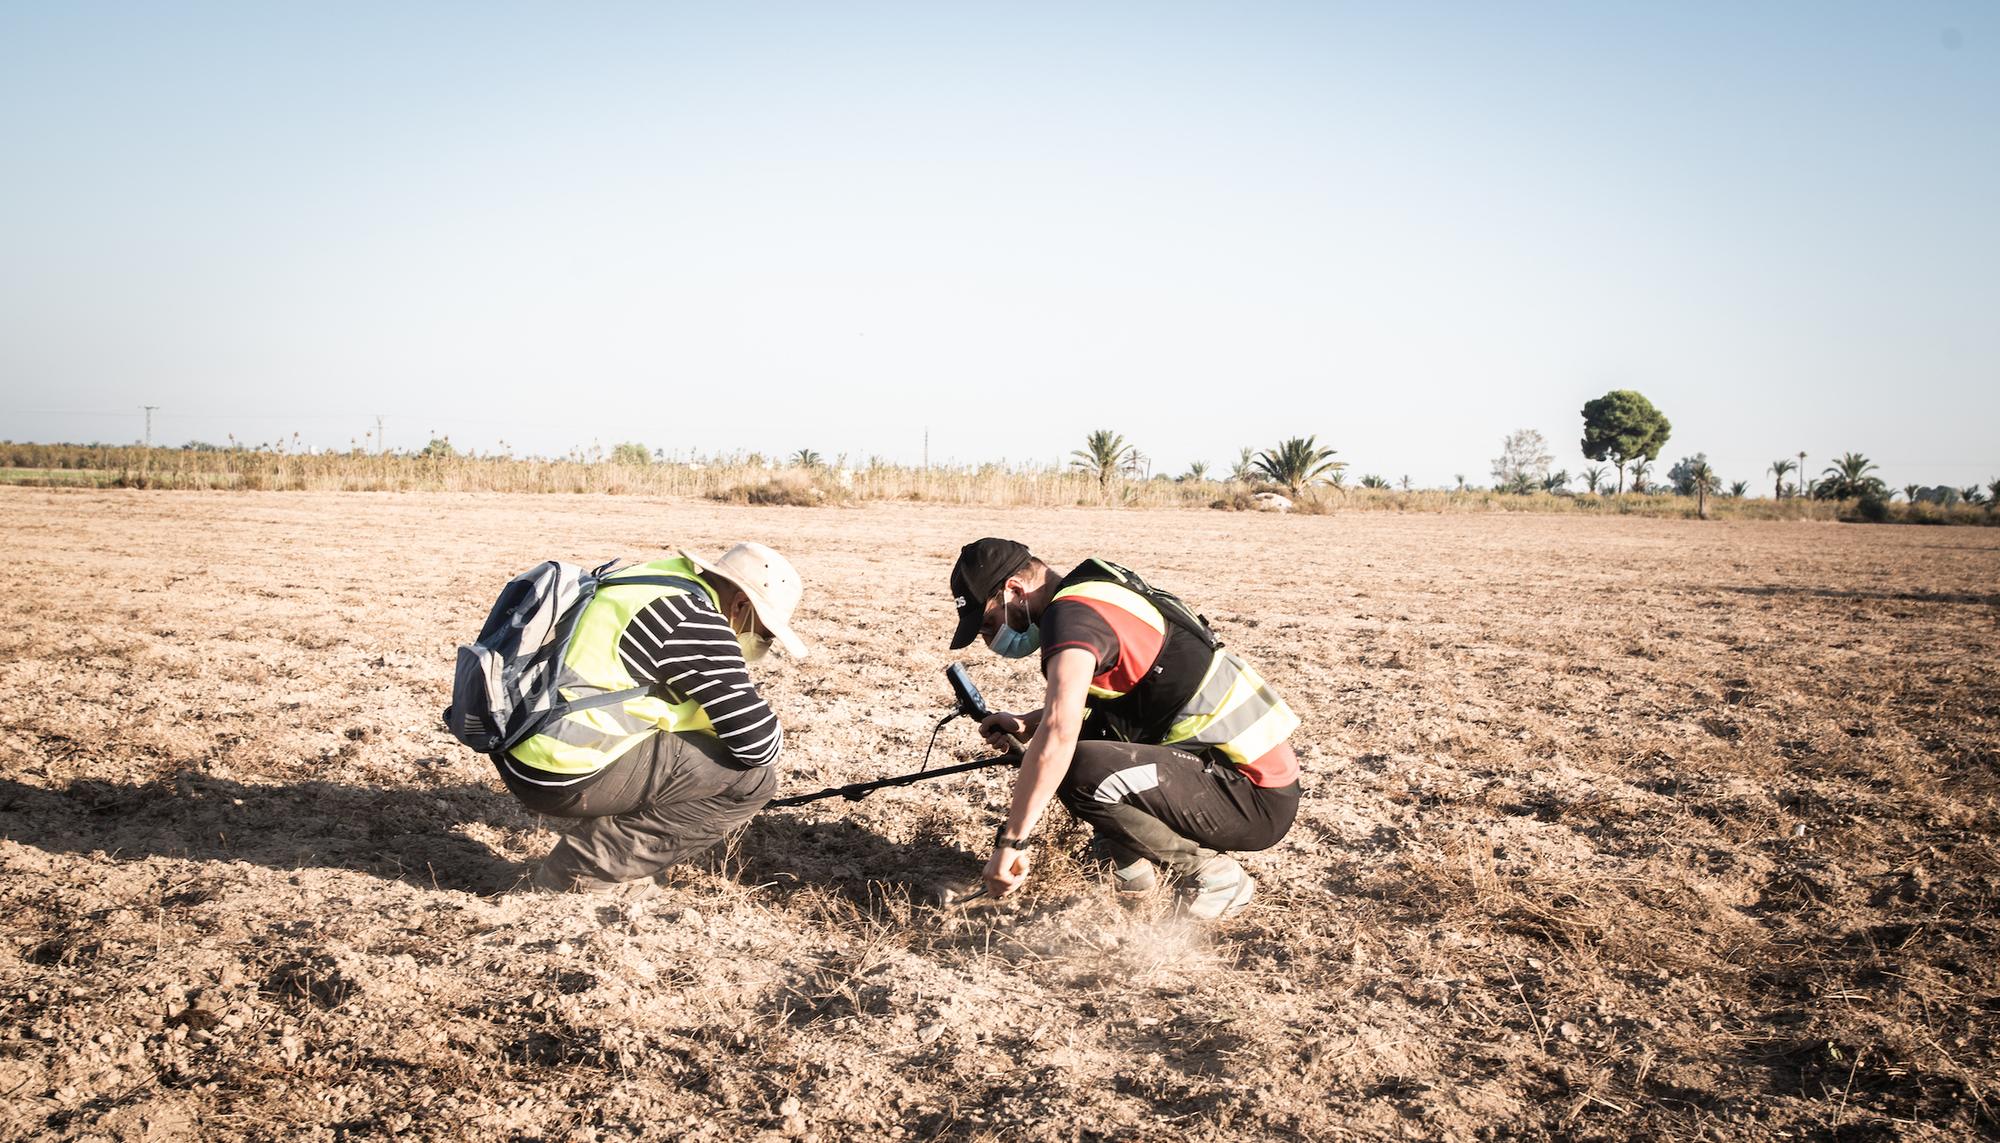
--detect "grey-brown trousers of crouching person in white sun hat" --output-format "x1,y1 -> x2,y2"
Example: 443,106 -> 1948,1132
494,733 -> 778,889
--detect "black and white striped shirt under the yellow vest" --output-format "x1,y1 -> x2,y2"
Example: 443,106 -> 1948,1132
618,595 -> 784,765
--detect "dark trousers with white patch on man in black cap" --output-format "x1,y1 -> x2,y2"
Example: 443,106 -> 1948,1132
1056,741 -> 1298,873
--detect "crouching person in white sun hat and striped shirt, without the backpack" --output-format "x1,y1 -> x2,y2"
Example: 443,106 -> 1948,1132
494,544 -> 806,893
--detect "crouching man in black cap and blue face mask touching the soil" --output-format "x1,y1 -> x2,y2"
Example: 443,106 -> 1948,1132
952,538 -> 1298,919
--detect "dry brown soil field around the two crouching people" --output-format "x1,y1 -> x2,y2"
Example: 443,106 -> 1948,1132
0,490 -> 2000,1141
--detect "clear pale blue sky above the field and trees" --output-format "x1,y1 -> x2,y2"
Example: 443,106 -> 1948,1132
0,0 -> 2000,488
